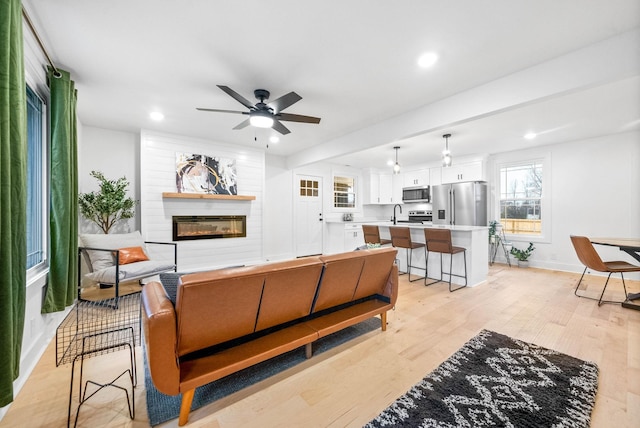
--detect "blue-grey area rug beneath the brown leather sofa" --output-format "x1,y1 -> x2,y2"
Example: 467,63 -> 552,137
143,317 -> 380,426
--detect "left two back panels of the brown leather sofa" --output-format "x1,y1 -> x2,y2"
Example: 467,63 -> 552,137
175,257 -> 322,356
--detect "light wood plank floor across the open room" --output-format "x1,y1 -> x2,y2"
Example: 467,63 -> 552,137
0,265 -> 640,428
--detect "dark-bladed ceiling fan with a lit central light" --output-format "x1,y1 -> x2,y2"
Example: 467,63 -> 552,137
196,85 -> 320,135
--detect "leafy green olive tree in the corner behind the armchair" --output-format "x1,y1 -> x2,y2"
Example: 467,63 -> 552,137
78,171 -> 137,234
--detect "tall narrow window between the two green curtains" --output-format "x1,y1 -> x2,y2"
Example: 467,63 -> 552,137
27,86 -> 47,269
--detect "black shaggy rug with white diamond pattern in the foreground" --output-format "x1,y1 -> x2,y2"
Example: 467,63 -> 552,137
366,330 -> 598,428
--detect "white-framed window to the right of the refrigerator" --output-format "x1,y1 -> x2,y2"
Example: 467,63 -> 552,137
499,160 -> 546,236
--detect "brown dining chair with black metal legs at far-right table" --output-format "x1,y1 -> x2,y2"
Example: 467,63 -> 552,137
571,235 -> 640,306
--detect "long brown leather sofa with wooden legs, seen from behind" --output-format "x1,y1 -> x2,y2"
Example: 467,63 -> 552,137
142,248 -> 398,426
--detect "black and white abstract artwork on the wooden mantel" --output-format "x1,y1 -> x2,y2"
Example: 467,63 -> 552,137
176,153 -> 238,195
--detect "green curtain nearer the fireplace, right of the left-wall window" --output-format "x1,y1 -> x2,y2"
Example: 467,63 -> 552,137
42,67 -> 78,313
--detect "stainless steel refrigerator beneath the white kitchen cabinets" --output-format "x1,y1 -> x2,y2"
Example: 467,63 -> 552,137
431,181 -> 488,226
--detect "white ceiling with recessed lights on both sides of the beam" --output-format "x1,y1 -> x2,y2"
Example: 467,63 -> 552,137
24,0 -> 640,167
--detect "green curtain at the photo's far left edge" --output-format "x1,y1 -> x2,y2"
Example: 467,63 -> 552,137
0,0 -> 27,407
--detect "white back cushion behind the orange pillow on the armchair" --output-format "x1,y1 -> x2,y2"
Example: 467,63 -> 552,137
80,230 -> 149,272
